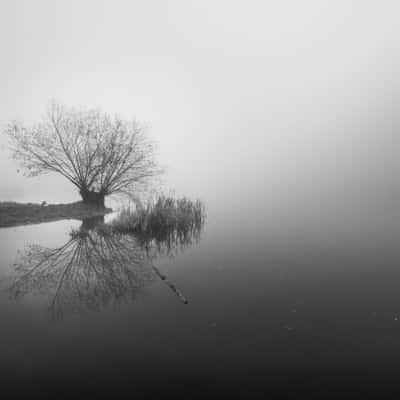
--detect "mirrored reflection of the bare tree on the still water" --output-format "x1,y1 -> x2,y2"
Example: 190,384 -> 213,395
10,216 -> 203,318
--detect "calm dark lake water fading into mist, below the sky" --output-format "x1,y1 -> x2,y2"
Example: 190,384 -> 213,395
0,200 -> 400,398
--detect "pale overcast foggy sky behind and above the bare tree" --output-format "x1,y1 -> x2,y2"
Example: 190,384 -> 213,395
0,0 -> 400,222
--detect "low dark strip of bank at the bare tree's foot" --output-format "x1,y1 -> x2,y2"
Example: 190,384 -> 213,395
0,202 -> 112,227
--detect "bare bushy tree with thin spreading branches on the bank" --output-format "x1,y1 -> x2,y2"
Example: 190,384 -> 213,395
6,103 -> 161,207
